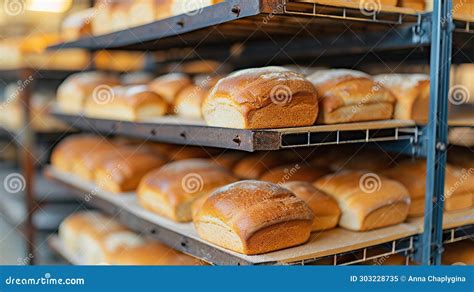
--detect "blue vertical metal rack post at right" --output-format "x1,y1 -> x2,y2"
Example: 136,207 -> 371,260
418,0 -> 453,265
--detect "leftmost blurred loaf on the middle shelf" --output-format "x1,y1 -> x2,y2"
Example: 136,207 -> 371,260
57,72 -> 119,114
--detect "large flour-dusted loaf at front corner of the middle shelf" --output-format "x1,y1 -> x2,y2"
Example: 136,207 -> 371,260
202,67 -> 318,129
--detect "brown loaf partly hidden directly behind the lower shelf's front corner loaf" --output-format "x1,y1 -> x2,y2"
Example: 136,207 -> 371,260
281,181 -> 341,231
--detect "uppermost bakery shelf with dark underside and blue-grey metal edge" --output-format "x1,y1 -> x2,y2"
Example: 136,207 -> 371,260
50,0 -> 429,50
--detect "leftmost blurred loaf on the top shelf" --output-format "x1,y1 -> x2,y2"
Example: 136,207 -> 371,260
61,8 -> 94,41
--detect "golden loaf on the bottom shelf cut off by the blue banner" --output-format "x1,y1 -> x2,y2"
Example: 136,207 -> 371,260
108,241 -> 205,266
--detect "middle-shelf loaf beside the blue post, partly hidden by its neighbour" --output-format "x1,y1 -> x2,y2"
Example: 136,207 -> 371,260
374,74 -> 430,122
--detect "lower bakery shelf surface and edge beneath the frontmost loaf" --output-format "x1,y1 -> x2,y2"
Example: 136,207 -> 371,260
45,167 -> 418,265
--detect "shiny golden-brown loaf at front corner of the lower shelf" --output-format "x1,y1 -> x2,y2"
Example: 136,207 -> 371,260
194,181 -> 314,255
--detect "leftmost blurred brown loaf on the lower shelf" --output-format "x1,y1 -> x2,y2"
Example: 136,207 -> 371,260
51,134 -> 104,173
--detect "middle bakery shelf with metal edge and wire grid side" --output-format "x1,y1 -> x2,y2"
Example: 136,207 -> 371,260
52,111 -> 419,151
